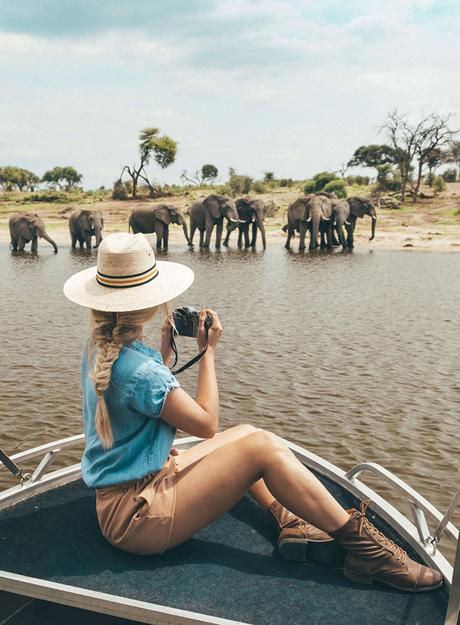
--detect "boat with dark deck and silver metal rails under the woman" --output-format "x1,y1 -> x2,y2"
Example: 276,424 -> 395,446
0,434 -> 460,625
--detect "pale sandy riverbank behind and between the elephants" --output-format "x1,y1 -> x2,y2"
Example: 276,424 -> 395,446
0,183 -> 460,252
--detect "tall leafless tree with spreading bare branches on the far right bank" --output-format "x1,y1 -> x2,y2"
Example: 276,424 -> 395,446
381,109 -> 455,202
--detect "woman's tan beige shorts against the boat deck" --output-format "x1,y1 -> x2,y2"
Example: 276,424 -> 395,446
96,449 -> 179,555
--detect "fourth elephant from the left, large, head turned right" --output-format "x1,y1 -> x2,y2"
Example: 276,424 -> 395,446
190,194 -> 240,250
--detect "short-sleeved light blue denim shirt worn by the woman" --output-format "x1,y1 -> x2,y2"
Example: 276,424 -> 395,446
81,341 -> 179,488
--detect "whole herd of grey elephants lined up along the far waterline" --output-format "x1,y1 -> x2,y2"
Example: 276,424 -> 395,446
9,194 -> 377,252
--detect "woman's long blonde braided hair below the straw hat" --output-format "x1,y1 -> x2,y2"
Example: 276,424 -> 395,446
88,304 -> 169,449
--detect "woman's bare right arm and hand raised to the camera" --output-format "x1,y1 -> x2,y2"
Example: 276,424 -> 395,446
160,308 -> 222,438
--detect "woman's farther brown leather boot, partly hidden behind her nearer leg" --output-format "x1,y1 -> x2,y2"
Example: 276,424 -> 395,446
267,499 -> 334,562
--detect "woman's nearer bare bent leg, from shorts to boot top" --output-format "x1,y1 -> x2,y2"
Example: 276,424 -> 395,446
169,431 -> 349,547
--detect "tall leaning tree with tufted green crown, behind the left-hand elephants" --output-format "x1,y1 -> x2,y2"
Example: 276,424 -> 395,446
120,128 -> 177,198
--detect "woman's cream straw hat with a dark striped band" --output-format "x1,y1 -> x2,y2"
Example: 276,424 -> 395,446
64,232 -> 195,312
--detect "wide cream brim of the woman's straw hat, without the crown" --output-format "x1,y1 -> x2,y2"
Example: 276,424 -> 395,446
64,261 -> 195,312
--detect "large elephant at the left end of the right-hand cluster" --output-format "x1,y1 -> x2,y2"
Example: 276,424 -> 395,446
285,194 -> 332,251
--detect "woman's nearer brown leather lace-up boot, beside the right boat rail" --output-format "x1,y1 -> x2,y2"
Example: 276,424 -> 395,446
331,501 -> 443,592
